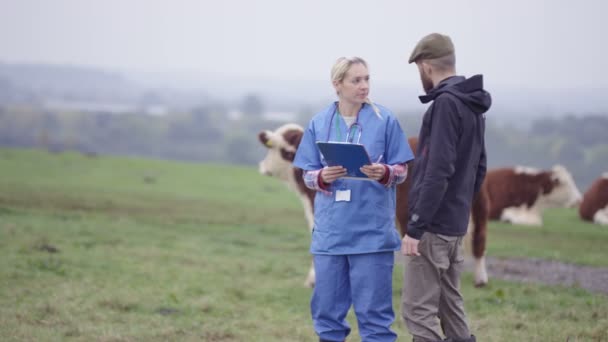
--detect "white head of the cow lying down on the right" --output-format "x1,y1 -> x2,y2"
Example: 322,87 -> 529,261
544,165 -> 583,207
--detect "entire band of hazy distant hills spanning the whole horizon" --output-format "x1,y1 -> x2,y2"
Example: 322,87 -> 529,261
0,63 -> 608,120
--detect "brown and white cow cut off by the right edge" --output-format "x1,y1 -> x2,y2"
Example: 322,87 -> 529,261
578,172 -> 608,225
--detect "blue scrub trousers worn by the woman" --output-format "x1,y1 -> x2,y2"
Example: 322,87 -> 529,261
310,251 -> 397,342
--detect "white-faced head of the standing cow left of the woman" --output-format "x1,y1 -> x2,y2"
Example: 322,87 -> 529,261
258,124 -> 304,180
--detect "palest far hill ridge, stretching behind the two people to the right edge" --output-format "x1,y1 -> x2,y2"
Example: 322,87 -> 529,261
129,68 -> 608,117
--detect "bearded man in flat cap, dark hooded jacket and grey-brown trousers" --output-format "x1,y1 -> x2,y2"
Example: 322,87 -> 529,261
401,33 -> 491,342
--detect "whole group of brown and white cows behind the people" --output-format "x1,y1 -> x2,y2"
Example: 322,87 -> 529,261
258,124 -> 608,287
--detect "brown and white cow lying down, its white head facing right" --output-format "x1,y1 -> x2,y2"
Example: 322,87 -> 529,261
482,165 -> 582,226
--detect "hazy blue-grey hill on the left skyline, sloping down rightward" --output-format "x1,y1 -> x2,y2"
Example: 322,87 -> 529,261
0,63 -> 208,109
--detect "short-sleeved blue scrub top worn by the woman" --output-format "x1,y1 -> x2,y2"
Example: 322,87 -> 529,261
293,103 -> 414,255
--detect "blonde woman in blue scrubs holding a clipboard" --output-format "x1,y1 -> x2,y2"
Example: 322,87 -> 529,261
294,57 -> 414,342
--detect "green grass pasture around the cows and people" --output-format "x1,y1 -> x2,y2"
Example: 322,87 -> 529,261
0,149 -> 608,341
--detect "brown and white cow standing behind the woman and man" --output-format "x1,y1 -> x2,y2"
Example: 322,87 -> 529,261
258,124 -> 488,287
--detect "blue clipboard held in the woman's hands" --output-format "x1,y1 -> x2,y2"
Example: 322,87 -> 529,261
317,141 -> 372,180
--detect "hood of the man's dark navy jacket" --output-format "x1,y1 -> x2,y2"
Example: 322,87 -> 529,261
419,75 -> 492,115
